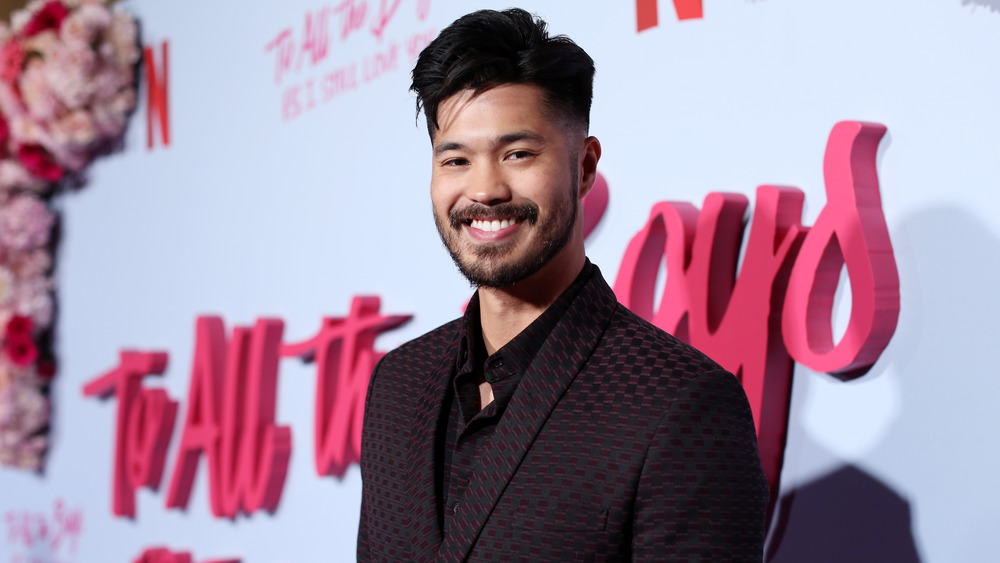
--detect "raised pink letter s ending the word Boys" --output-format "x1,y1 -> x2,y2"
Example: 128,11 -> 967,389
783,121 -> 899,379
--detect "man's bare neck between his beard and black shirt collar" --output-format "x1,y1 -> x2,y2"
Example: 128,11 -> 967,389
479,254 -> 586,354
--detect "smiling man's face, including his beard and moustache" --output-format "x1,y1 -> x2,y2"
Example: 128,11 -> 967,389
431,84 -> 582,287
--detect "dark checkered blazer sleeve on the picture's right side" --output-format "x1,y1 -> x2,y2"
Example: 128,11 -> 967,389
632,370 -> 768,561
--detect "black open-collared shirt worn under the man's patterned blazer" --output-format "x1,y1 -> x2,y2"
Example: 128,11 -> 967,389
442,260 -> 594,534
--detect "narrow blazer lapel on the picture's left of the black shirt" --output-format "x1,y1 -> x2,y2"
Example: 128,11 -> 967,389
404,332 -> 459,561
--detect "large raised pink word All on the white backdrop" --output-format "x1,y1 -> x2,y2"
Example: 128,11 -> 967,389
167,317 -> 292,518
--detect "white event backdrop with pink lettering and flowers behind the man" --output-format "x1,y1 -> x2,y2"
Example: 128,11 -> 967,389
0,0 -> 1000,563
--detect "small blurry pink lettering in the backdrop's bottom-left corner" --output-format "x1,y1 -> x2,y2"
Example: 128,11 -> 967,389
3,499 -> 83,563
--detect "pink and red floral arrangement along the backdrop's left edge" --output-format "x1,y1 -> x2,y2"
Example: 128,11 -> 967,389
0,0 -> 140,470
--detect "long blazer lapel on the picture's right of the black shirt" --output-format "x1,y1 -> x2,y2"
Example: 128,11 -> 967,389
438,267 -> 617,561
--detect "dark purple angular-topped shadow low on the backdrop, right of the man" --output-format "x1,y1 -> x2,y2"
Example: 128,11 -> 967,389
768,465 -> 920,563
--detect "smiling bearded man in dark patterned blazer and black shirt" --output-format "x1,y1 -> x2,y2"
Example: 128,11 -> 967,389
358,6 -> 768,561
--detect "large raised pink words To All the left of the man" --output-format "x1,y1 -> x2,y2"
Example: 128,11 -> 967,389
83,296 -> 411,518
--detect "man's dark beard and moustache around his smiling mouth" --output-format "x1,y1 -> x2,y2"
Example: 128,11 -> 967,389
434,178 -> 577,288
